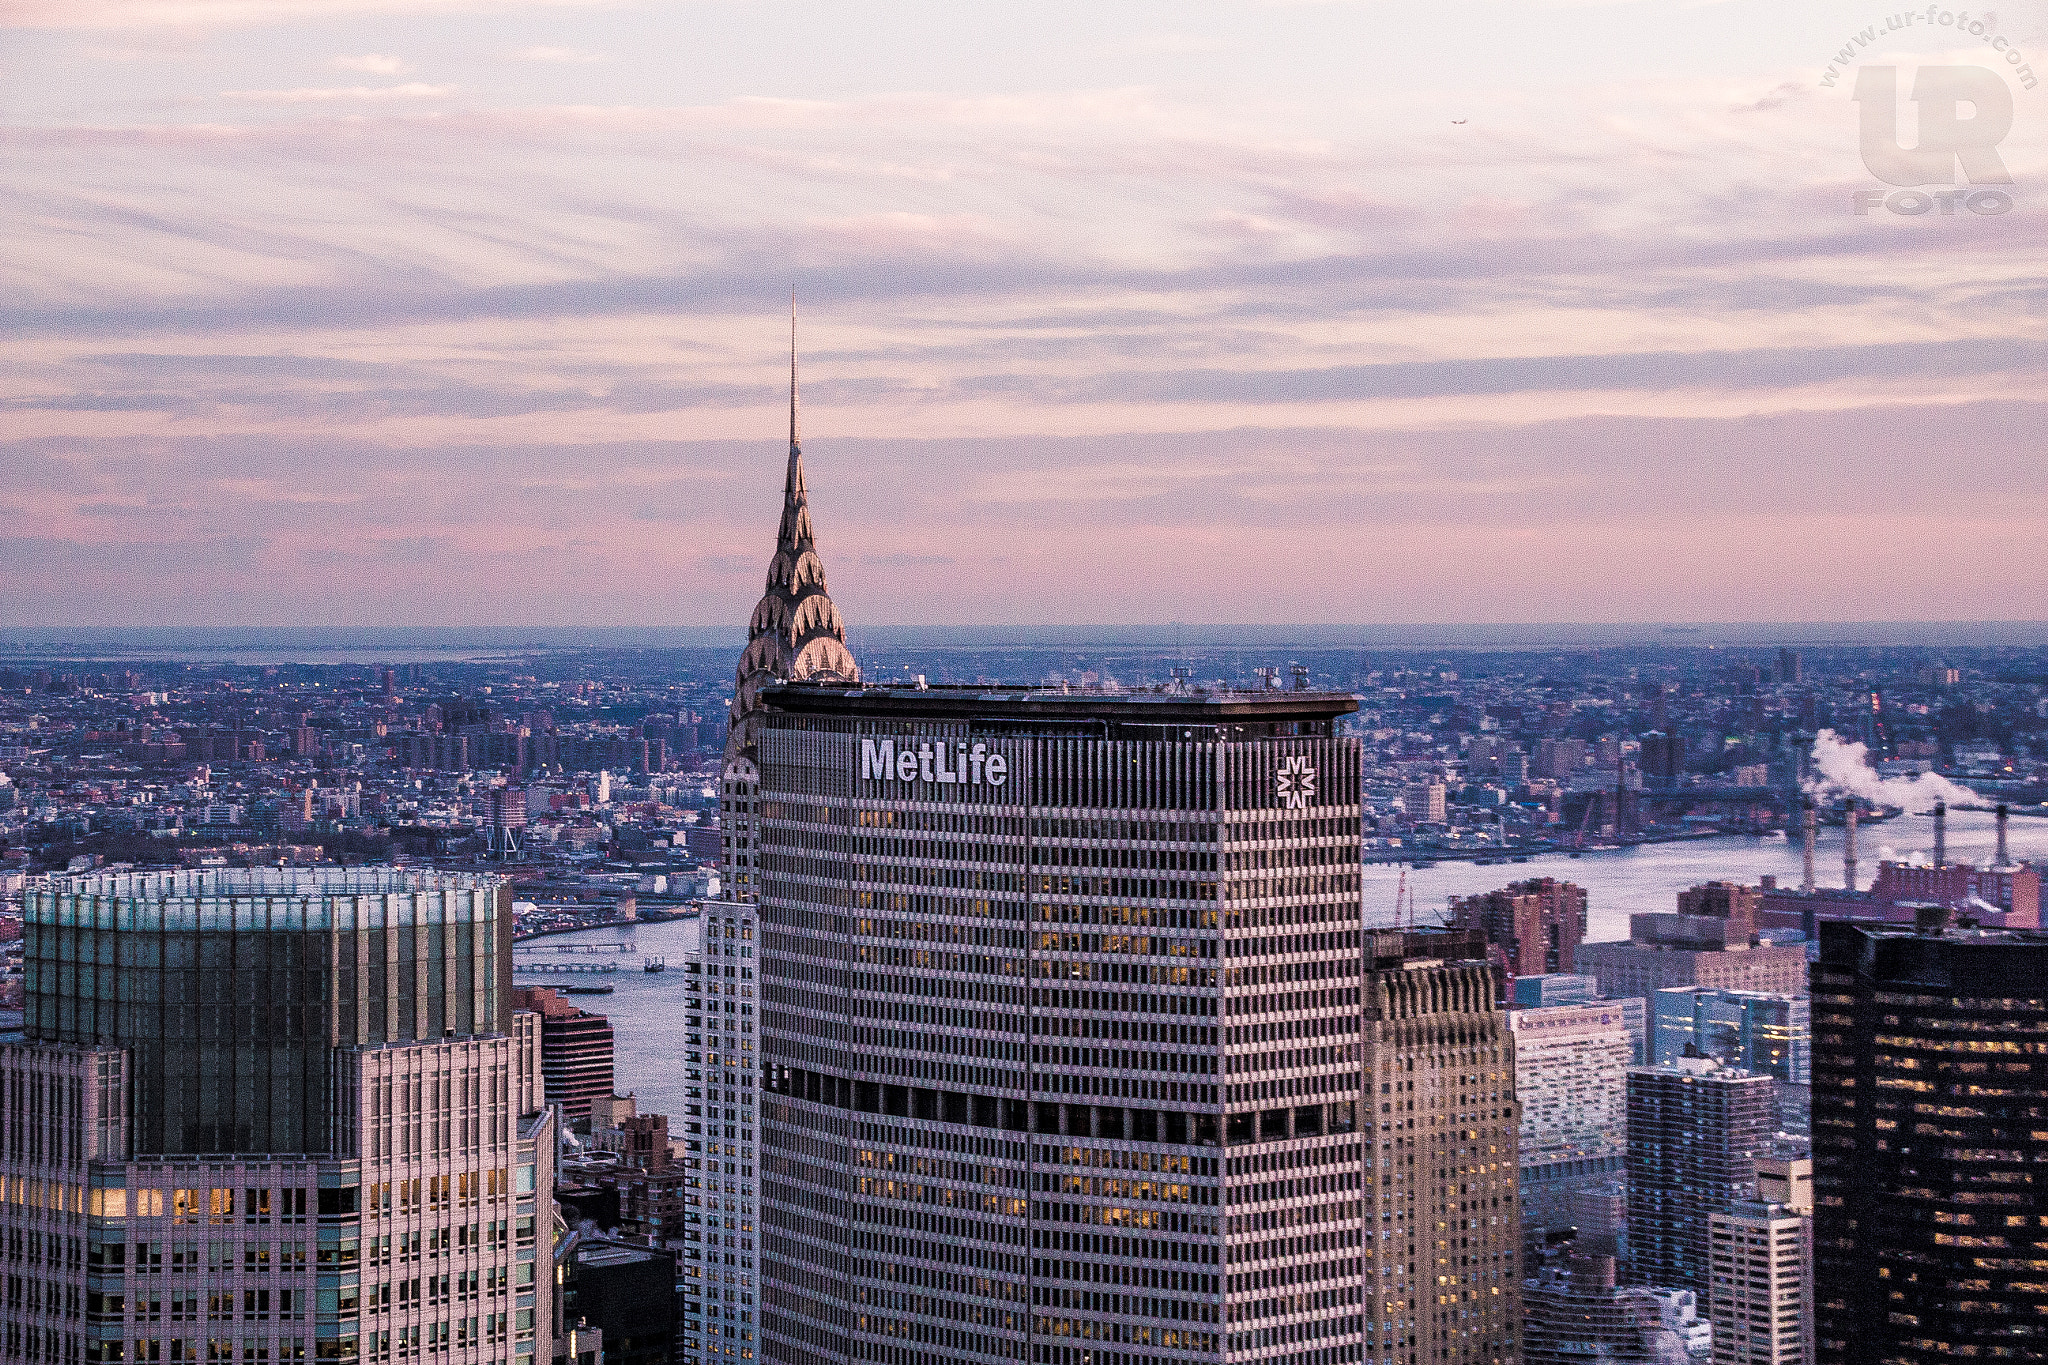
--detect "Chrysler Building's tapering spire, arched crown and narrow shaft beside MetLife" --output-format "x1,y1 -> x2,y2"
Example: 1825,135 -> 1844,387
719,306 -> 860,900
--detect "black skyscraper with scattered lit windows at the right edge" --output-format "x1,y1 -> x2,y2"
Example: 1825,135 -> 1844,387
1812,923 -> 2048,1363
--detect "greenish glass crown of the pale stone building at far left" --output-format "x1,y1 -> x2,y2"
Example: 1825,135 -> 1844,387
23,868 -> 512,1154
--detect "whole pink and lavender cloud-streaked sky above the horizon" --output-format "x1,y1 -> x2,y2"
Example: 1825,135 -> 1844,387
0,0 -> 2048,624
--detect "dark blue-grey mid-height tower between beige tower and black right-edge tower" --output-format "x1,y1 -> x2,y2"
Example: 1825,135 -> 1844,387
1628,1058 -> 1778,1297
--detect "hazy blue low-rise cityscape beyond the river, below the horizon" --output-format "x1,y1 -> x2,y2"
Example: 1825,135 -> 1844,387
0,645 -> 2048,900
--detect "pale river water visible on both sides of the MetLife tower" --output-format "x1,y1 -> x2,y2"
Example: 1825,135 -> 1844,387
532,810 -> 2048,1113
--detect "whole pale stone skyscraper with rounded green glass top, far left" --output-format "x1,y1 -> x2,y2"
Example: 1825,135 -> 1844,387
0,868 -> 557,1365
